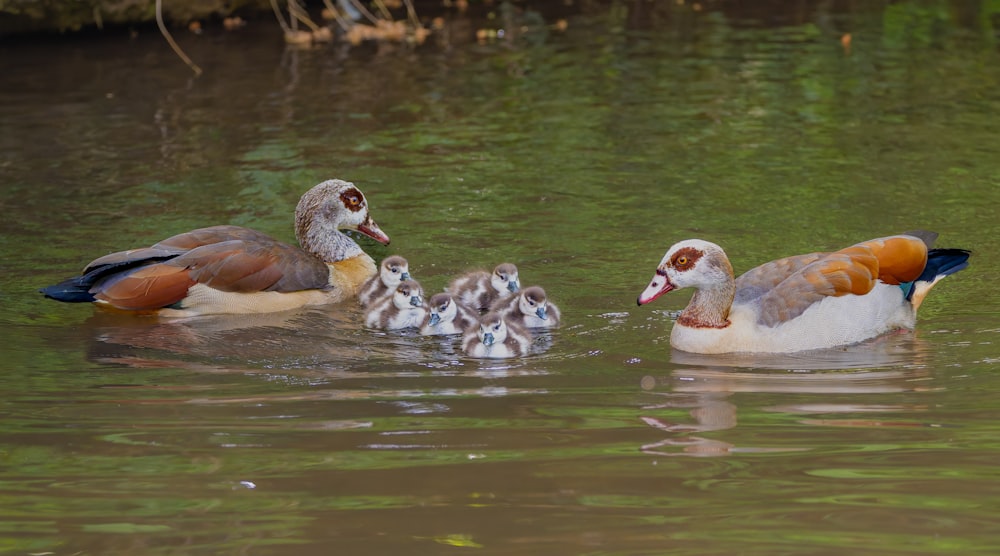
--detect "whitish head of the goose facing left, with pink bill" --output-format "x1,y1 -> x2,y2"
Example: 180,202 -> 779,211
637,239 -> 733,305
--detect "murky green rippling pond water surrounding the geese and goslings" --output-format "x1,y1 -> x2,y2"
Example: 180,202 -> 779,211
0,2 -> 1000,555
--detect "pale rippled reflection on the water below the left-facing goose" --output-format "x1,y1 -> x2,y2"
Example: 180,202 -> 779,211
640,333 -> 934,456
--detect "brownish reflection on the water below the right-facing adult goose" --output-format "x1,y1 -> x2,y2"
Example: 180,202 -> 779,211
83,306 -> 433,375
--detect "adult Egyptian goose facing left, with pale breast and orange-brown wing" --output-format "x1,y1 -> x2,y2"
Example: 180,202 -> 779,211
638,232 -> 969,353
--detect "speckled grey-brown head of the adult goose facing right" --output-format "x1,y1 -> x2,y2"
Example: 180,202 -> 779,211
295,180 -> 389,249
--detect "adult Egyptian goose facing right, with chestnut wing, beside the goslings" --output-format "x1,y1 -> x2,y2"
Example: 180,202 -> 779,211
41,180 -> 389,317
